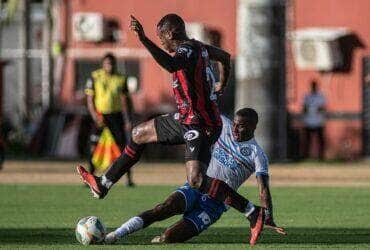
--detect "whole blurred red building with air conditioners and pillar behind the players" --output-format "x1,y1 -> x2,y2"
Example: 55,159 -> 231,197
0,0 -> 370,160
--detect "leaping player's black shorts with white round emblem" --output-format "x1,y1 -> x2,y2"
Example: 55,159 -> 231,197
154,114 -> 221,166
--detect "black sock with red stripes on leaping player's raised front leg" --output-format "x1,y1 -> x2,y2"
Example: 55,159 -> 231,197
105,140 -> 144,184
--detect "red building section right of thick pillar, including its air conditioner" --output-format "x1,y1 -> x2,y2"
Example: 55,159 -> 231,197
286,0 -> 370,159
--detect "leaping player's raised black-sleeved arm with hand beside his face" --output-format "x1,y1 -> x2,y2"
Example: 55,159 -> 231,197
130,15 -> 185,73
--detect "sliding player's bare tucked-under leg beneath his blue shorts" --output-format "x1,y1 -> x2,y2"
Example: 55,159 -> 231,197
161,219 -> 199,243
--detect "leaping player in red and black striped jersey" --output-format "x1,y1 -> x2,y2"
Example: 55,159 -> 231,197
77,14 -> 265,244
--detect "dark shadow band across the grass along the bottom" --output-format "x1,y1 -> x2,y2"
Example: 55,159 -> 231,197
0,227 -> 370,245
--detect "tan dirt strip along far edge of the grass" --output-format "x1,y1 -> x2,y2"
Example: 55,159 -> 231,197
0,161 -> 370,187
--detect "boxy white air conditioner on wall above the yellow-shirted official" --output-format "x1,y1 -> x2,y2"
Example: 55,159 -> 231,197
73,12 -> 104,42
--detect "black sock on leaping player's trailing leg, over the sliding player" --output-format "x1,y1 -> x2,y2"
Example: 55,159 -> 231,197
200,175 -> 249,214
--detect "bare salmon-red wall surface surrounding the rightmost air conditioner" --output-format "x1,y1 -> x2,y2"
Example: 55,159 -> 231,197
287,0 -> 370,158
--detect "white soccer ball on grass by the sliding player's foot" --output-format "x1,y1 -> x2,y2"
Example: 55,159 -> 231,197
76,216 -> 107,245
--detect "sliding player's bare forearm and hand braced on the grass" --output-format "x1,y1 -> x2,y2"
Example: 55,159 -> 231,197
257,175 -> 286,235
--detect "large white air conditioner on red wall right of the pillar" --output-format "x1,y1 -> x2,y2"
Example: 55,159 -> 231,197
292,28 -> 349,71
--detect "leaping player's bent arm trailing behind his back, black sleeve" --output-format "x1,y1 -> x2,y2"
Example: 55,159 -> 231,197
206,45 -> 231,92
